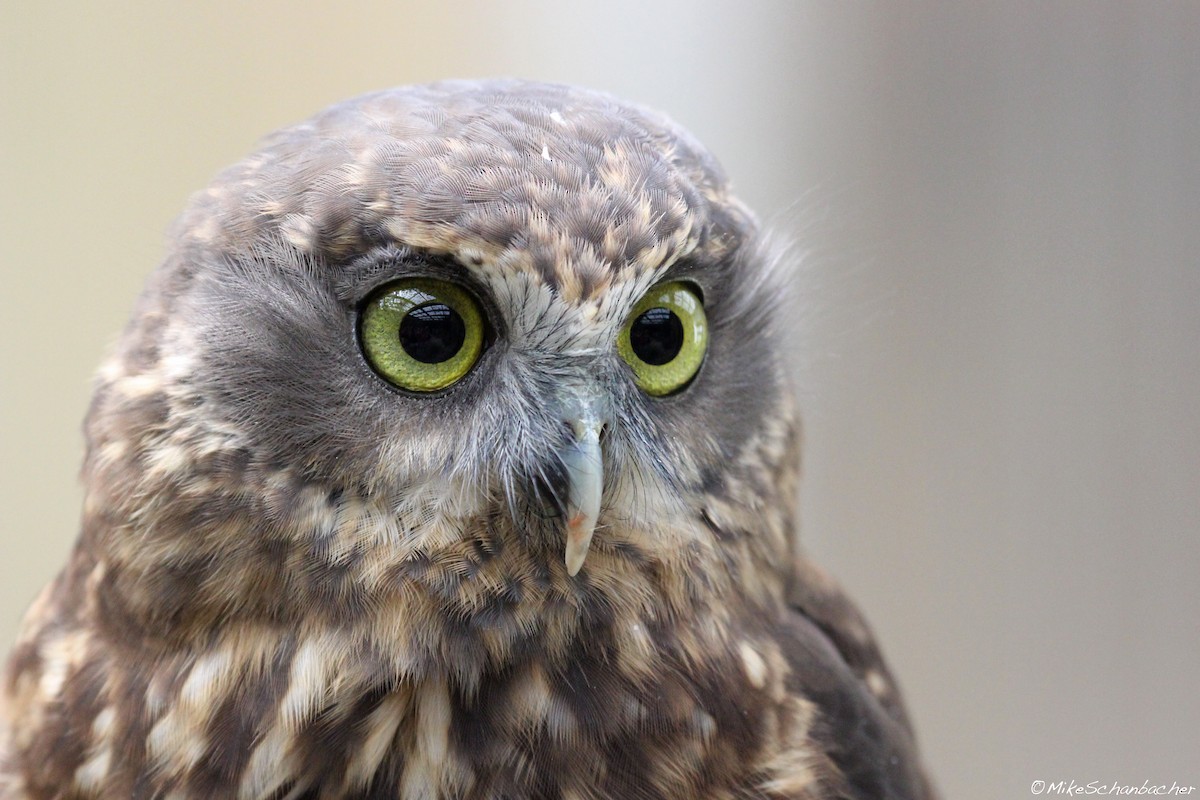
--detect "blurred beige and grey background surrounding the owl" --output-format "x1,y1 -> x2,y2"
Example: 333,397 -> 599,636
0,0 -> 1200,798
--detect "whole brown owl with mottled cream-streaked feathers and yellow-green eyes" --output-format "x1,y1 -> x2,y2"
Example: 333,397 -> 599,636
0,82 -> 932,800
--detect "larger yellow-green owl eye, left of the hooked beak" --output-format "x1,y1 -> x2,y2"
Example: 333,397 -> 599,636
359,278 -> 484,392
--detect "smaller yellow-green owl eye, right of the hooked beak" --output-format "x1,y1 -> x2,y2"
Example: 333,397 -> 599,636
617,281 -> 708,397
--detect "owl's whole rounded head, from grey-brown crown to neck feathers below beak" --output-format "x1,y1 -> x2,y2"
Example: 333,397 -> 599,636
84,82 -> 794,647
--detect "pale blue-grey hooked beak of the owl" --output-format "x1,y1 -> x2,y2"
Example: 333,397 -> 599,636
559,402 -> 605,576
